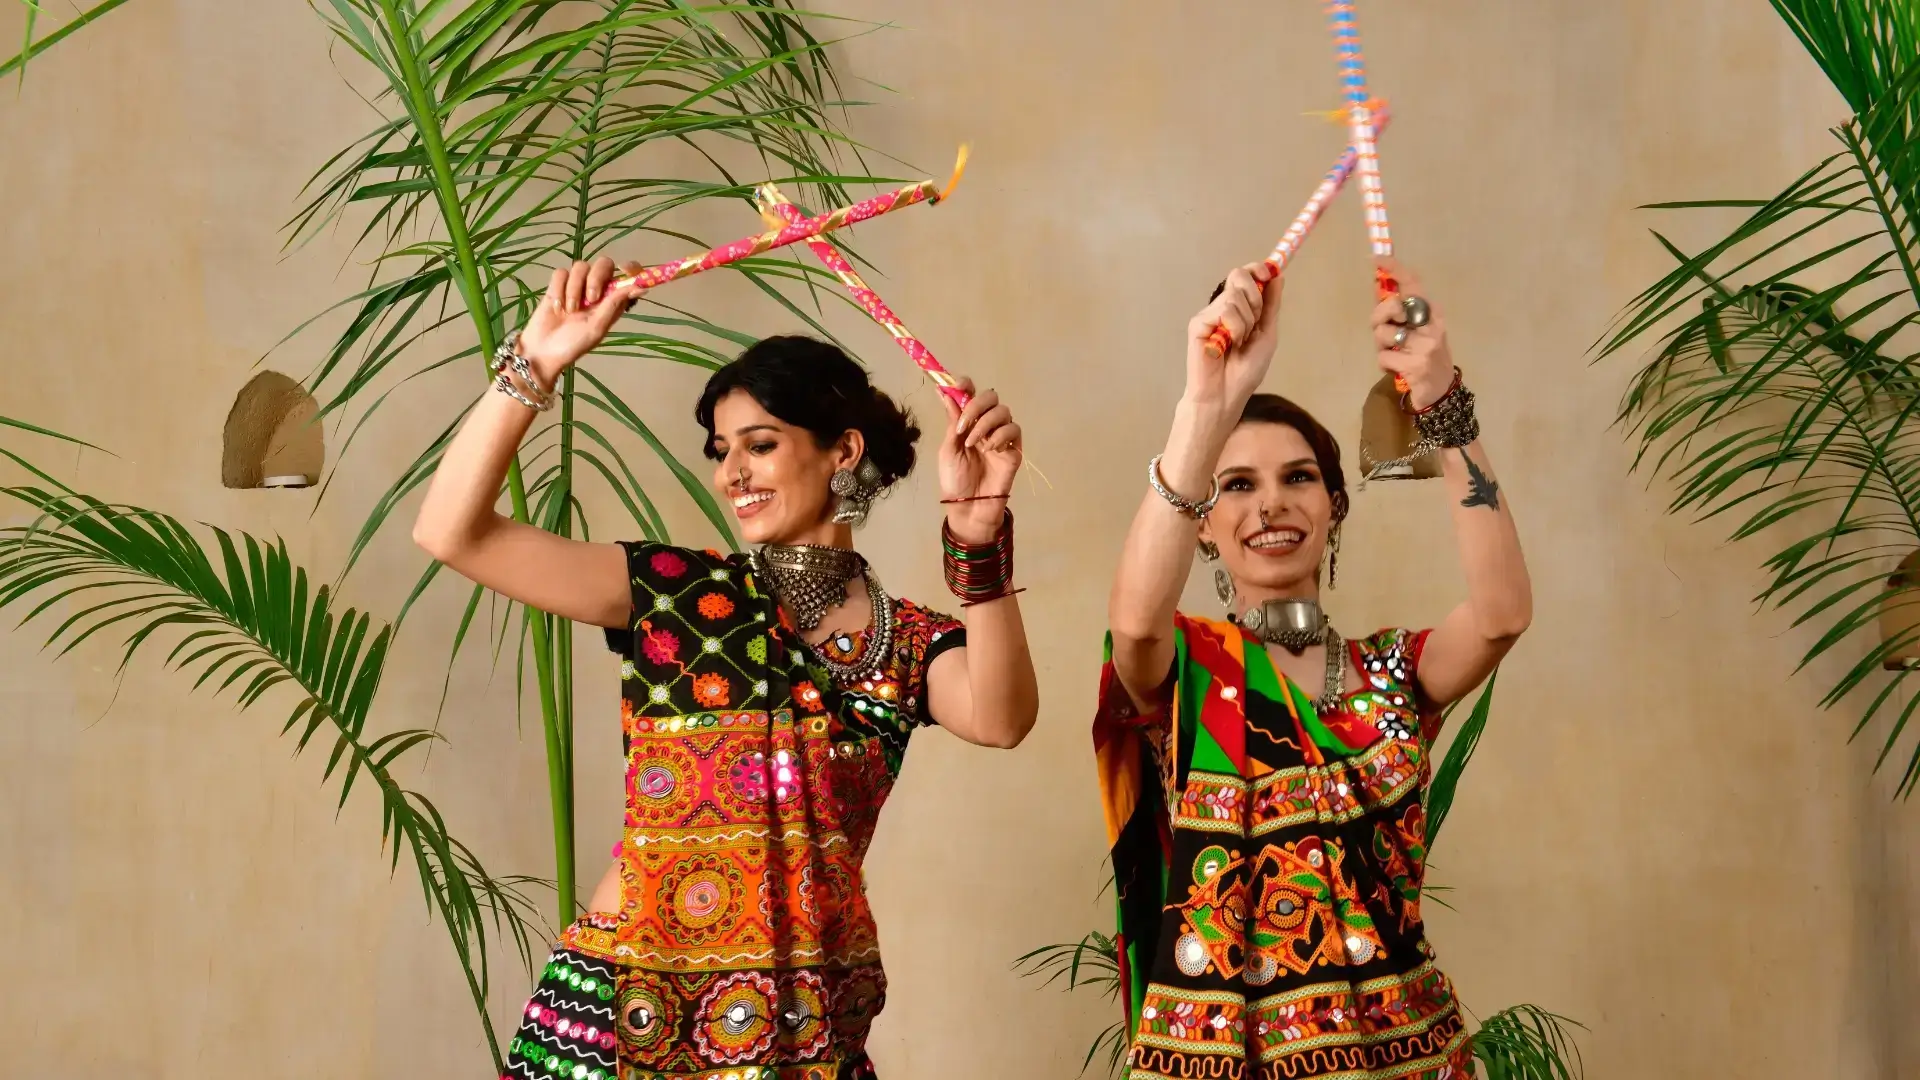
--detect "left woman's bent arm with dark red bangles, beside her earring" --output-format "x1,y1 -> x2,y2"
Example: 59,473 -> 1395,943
927,379 -> 1041,748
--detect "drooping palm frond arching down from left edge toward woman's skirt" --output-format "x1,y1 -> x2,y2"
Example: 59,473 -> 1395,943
0,486 -> 545,1067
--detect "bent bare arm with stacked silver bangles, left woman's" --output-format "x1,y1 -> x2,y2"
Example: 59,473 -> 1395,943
413,259 -> 637,626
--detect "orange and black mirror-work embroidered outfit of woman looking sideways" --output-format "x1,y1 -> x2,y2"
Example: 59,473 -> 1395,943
507,544 -> 966,1080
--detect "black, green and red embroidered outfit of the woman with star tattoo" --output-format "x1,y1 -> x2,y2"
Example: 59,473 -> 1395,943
1094,615 -> 1473,1080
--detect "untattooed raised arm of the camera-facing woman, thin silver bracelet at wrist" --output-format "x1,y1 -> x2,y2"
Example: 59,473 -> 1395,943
1108,255 -> 1281,707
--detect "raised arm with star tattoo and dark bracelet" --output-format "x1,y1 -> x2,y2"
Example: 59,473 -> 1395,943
1373,255 -> 1534,705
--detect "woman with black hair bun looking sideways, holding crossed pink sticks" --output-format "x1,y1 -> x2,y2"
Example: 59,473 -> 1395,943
413,259 -> 1039,1080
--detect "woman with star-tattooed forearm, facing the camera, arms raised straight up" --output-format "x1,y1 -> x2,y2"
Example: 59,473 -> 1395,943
1094,255 -> 1532,1080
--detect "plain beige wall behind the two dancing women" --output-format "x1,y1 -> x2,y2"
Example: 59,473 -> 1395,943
0,0 -> 1920,1080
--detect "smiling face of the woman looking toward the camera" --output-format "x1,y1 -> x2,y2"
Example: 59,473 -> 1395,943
1200,421 -> 1336,605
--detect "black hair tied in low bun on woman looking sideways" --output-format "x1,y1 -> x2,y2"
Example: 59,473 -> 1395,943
693,334 -> 920,484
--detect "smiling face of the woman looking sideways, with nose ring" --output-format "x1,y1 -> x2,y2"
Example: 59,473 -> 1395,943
707,390 -> 864,546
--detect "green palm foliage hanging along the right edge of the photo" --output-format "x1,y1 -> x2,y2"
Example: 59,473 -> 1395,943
1599,31 -> 1920,798
